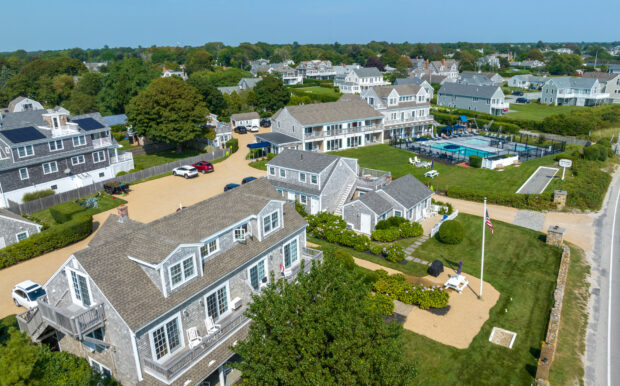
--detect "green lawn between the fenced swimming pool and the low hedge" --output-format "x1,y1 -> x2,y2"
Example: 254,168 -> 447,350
332,144 -> 556,193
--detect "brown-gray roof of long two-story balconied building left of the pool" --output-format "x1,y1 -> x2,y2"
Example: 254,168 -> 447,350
285,98 -> 383,126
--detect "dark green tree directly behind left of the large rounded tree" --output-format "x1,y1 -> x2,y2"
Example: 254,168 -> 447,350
98,58 -> 160,114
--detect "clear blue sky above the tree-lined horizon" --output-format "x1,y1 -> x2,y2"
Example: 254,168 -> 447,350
0,0 -> 620,51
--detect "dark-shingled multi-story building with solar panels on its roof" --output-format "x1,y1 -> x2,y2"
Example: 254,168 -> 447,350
0,101 -> 134,207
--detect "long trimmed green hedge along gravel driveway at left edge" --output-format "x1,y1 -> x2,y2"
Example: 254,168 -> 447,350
0,215 -> 93,268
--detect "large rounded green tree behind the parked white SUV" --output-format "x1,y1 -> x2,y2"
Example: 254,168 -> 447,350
127,77 -> 209,152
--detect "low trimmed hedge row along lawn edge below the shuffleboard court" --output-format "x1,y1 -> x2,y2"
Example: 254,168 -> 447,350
446,186 -> 555,210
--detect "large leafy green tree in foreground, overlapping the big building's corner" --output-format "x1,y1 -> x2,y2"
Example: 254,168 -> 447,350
231,256 -> 415,385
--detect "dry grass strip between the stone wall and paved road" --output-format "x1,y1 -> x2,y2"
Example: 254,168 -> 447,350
549,246 -> 590,385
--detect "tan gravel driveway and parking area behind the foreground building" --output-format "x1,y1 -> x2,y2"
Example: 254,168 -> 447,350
0,129 -> 270,318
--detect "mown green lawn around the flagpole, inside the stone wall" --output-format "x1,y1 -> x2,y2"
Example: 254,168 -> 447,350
402,214 -> 561,385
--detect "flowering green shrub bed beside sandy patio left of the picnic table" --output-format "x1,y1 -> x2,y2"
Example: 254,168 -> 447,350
373,274 -> 450,310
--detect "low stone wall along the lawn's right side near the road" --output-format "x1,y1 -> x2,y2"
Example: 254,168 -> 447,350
536,245 -> 570,385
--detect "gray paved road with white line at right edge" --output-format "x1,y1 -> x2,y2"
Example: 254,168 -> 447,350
585,173 -> 620,385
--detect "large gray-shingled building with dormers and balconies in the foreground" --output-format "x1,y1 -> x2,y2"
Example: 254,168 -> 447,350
18,178 -> 322,385
